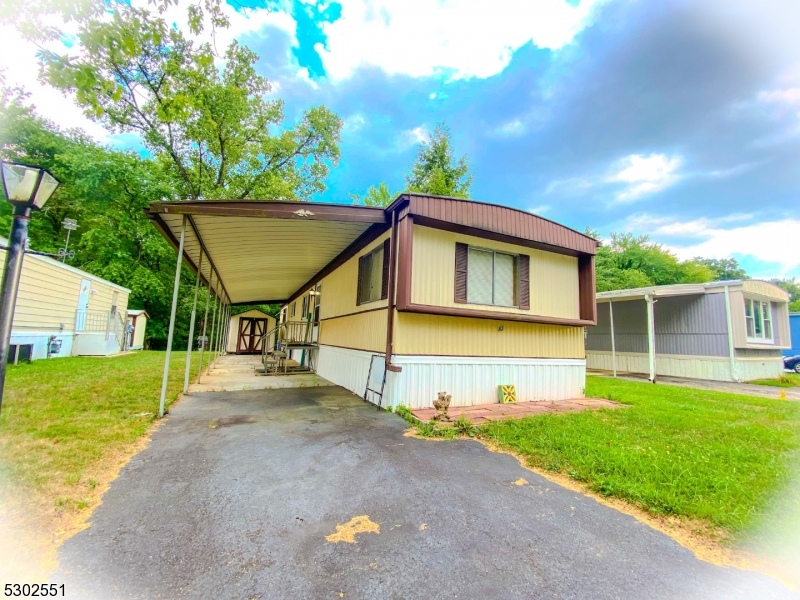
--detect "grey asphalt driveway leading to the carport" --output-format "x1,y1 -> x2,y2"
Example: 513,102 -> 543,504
52,386 -> 797,599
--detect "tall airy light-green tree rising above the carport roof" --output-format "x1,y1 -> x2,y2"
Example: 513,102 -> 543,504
42,5 -> 342,200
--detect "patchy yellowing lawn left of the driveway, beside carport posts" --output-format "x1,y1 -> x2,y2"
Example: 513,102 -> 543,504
0,352 -> 203,512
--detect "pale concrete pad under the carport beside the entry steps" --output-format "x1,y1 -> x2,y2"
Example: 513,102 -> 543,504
189,354 -> 333,394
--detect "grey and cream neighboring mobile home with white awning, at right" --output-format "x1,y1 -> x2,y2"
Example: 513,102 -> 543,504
586,280 -> 791,381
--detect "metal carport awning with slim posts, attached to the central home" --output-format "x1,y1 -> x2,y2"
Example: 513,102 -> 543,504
146,200 -> 390,416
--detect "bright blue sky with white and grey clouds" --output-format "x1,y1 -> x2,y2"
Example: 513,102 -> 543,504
1,0 -> 800,277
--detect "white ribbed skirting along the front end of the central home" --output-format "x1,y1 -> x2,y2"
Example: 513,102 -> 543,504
384,355 -> 586,408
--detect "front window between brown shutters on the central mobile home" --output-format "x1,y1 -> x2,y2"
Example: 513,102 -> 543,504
467,247 -> 517,306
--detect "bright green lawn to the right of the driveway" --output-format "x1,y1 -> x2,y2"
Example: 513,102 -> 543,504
479,377 -> 800,534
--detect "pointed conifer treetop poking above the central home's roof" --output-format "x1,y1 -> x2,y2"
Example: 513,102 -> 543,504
406,121 -> 472,198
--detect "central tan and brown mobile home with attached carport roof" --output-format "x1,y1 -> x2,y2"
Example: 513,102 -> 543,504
148,194 -> 598,407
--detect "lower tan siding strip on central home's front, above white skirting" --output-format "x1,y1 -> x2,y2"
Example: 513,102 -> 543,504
394,313 -> 584,358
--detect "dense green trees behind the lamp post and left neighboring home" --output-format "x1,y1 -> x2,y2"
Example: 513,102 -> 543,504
0,87 -> 205,348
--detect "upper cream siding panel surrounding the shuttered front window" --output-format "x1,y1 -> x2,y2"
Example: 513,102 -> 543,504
411,225 -> 580,319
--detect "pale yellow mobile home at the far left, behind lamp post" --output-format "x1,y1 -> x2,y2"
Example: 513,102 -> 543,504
0,238 -> 130,363
